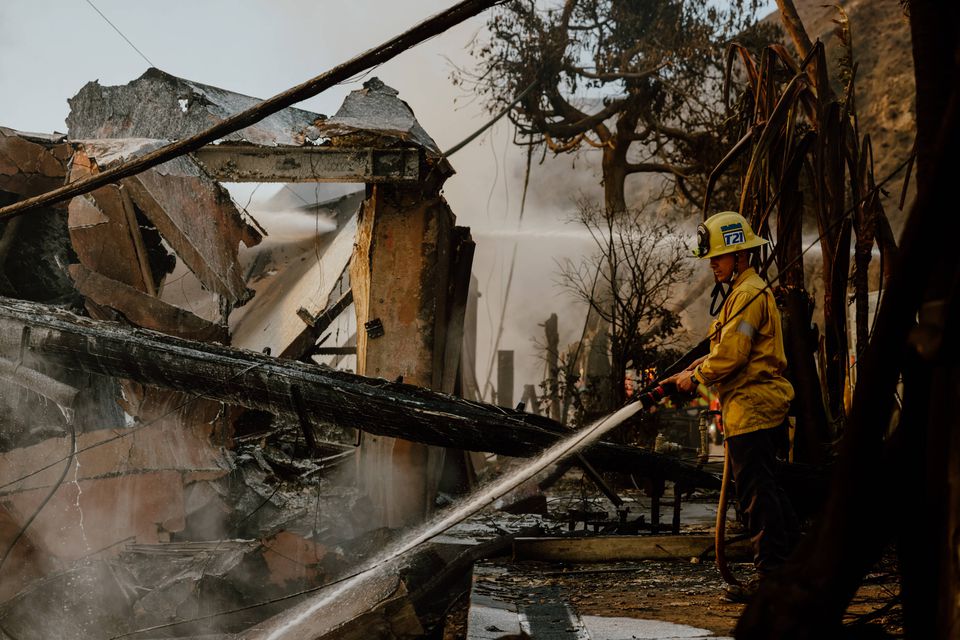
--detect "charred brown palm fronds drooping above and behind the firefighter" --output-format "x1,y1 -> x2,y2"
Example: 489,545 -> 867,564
703,8 -> 896,448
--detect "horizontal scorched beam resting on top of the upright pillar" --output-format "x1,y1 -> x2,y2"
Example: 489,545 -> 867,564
193,144 -> 423,183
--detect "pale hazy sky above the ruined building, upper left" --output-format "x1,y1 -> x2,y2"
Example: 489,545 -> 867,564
0,0 -> 472,135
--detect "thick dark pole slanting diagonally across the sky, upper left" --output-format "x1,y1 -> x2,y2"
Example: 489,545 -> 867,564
0,0 -> 499,220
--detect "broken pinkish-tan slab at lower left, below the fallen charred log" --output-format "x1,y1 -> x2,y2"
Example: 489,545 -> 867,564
0,412 -> 226,596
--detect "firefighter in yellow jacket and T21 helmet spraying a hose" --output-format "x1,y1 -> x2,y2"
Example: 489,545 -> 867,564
670,211 -> 797,600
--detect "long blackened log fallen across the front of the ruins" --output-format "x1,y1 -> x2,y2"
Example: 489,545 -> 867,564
0,298 -> 719,487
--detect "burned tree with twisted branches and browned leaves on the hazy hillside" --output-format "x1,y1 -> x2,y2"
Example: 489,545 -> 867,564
457,0 -> 769,212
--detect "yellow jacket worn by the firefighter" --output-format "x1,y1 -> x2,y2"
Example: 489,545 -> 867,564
694,268 -> 793,438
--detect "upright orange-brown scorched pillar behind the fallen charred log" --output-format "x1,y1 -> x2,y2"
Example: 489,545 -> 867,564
350,184 -> 453,527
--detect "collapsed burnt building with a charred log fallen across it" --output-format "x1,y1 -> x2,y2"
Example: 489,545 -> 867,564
0,69 -> 717,638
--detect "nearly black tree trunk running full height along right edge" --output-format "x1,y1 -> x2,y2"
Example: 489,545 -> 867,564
901,0 -> 960,638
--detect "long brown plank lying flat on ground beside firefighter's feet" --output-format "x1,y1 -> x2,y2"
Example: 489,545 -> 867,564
513,535 -> 750,562
